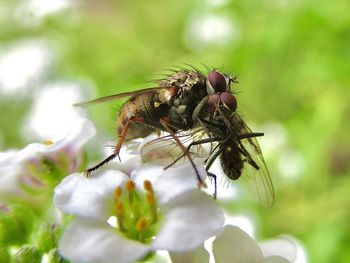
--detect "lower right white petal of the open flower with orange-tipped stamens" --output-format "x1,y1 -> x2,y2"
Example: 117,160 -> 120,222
152,190 -> 225,252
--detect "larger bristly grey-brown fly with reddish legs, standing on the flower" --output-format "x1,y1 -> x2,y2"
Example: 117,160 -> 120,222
75,68 -> 236,189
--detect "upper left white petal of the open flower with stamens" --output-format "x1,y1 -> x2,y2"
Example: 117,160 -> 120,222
54,170 -> 127,219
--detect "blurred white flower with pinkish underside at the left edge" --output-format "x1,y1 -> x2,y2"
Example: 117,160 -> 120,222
0,119 -> 95,197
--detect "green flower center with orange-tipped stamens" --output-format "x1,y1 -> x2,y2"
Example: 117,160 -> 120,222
114,180 -> 160,243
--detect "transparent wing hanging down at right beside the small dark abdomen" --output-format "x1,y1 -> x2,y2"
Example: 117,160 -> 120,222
237,119 -> 275,207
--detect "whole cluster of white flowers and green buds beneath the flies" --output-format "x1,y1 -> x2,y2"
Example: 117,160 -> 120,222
0,120 -> 296,263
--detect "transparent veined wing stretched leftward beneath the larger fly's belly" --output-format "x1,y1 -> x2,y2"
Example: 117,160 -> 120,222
140,130 -> 208,167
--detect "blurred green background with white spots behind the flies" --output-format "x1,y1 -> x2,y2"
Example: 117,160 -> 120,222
0,0 -> 350,263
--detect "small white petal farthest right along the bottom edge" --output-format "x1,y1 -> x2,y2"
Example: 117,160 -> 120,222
260,237 -> 298,262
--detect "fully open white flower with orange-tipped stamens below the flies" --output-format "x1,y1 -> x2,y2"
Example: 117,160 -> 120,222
54,159 -> 224,263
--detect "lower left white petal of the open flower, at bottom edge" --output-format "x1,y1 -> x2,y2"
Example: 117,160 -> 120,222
59,218 -> 149,263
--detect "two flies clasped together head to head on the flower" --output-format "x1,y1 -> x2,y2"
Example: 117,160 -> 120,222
75,68 -> 274,207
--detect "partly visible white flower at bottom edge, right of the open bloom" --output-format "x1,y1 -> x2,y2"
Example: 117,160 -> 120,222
213,225 -> 297,263
